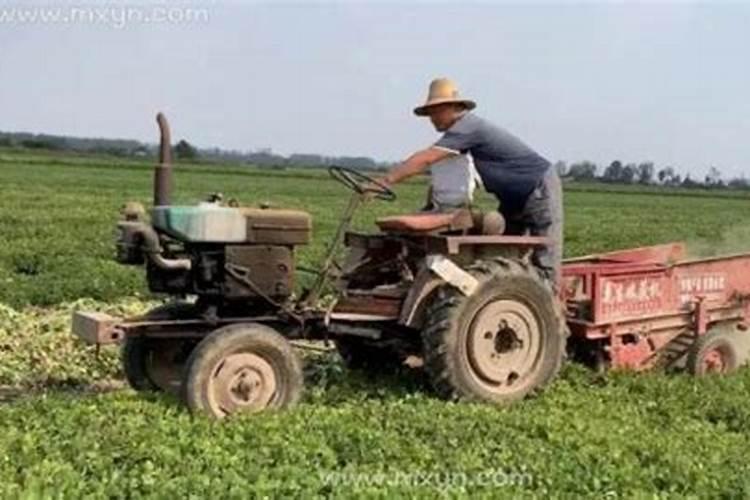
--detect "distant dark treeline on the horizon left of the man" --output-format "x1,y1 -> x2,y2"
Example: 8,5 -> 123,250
0,132 -> 389,170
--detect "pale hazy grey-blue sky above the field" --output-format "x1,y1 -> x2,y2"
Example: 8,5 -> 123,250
0,0 -> 750,177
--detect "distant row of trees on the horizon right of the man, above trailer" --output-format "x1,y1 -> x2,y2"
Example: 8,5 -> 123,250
555,160 -> 750,189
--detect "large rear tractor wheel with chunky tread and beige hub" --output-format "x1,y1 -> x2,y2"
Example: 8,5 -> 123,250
422,259 -> 567,404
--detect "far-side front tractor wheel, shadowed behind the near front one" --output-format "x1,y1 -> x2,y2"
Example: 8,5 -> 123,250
122,302 -> 196,394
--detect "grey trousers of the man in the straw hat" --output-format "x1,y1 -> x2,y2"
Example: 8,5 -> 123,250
500,167 -> 563,292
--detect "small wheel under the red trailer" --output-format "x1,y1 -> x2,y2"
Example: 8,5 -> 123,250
686,329 -> 740,377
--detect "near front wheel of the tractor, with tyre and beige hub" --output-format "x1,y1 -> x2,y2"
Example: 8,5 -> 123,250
183,323 -> 303,418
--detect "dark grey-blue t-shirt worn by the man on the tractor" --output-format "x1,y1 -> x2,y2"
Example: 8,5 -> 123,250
435,113 -> 550,214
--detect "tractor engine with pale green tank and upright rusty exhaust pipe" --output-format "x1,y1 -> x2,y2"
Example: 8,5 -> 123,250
116,114 -> 312,305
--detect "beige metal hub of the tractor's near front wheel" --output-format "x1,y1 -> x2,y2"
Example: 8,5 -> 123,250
209,353 -> 277,414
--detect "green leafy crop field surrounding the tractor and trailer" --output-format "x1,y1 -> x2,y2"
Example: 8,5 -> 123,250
0,150 -> 750,498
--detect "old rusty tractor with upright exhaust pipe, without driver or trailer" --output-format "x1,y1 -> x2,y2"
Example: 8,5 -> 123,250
72,113 -> 566,418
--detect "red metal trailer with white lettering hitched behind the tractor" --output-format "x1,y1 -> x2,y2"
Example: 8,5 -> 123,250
562,243 -> 750,375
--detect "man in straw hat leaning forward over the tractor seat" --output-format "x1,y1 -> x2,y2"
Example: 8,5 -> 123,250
381,78 -> 563,290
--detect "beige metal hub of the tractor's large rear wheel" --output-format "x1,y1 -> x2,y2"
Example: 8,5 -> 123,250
467,300 -> 541,391
